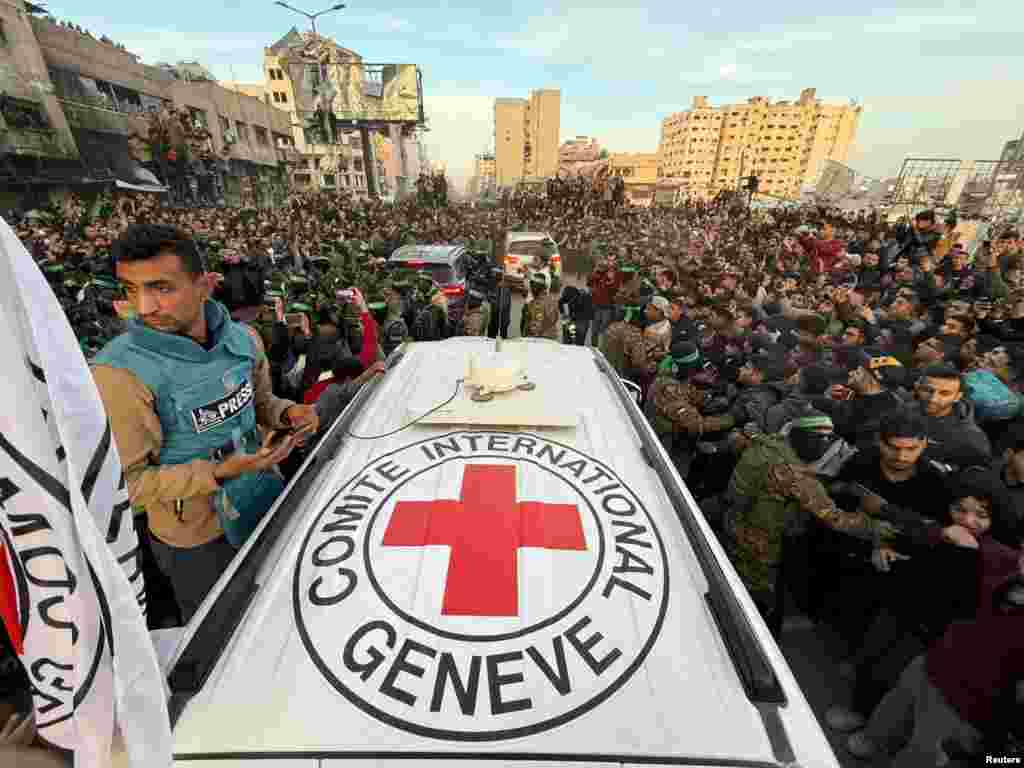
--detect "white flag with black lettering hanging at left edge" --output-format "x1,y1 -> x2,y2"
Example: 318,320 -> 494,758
0,219 -> 172,768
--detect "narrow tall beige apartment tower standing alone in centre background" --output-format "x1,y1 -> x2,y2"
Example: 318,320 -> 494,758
495,89 -> 561,186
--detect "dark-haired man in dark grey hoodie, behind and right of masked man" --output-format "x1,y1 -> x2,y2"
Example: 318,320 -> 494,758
913,365 -> 992,469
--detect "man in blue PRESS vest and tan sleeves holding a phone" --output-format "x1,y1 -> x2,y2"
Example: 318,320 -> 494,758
93,224 -> 318,622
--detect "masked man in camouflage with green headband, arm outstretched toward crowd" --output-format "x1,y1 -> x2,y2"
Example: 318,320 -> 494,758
726,410 -> 895,637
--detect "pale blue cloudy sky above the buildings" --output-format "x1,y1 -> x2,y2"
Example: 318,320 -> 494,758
48,0 -> 1024,188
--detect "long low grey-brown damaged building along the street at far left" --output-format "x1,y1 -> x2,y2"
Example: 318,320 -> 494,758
0,0 -> 291,206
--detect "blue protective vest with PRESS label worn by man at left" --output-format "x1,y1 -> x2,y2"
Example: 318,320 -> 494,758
95,301 -> 284,546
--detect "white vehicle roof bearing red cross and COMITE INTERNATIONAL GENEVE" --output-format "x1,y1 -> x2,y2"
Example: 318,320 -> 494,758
169,338 -> 838,768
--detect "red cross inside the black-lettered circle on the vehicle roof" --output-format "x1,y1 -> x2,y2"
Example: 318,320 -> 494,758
383,464 -> 587,616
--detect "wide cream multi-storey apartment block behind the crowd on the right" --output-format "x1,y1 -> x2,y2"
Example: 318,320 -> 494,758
657,88 -> 862,199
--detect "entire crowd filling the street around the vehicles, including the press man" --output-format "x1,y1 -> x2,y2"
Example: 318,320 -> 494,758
2,182 -> 1024,766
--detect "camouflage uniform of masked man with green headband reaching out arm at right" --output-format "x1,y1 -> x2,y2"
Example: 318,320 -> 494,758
726,434 -> 892,598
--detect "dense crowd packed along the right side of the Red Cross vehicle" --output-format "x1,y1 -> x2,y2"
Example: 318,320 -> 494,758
589,201 -> 1024,766
